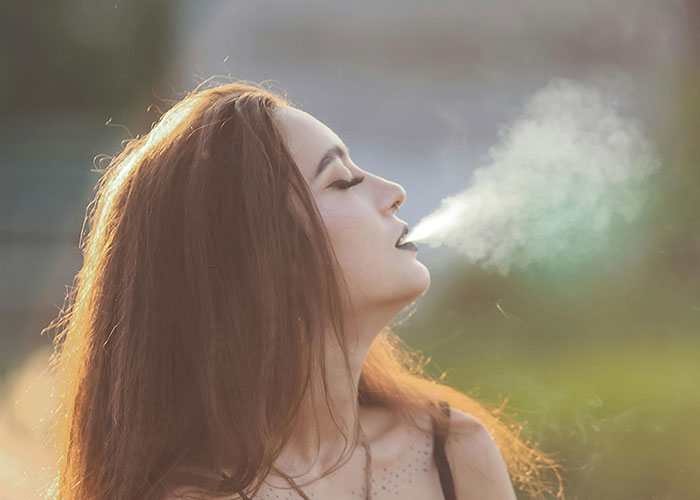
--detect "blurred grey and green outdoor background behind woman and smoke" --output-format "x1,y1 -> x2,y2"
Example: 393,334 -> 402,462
0,0 -> 700,500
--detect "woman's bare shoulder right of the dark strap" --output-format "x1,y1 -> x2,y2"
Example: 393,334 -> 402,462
445,408 -> 516,500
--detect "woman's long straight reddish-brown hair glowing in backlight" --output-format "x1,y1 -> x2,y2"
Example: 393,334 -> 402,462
45,82 -> 563,500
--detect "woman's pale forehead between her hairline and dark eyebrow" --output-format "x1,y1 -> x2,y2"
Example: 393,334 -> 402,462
273,106 -> 343,180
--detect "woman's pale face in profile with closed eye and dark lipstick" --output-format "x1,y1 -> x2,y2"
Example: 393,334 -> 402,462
274,107 -> 430,320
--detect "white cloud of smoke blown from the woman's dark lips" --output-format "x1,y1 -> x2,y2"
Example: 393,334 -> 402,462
406,80 -> 659,274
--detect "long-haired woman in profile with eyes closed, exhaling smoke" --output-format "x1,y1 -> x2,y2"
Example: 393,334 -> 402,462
45,82 -> 562,500
